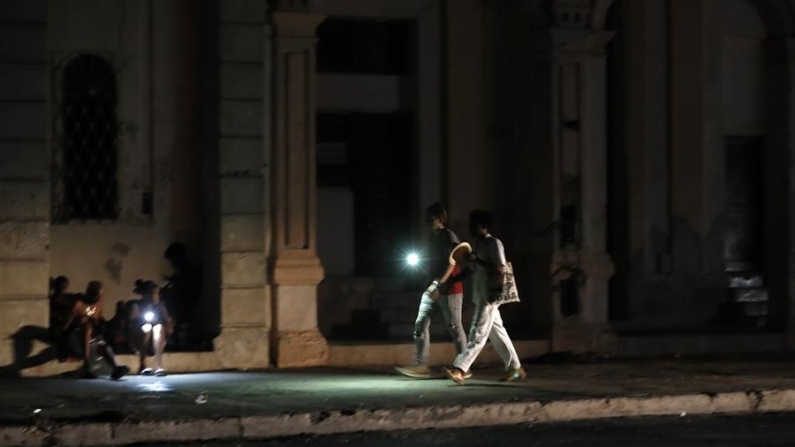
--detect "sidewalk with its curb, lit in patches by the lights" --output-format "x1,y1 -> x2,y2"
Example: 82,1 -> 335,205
0,359 -> 795,446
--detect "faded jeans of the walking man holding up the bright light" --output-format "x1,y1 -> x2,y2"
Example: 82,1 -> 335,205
414,293 -> 466,366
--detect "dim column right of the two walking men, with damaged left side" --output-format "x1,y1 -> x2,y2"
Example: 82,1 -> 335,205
552,30 -> 614,352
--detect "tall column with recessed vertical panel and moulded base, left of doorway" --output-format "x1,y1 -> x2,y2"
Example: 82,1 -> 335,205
270,6 -> 328,367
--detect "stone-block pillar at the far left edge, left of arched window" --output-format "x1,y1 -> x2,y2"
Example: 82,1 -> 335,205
0,2 -> 49,366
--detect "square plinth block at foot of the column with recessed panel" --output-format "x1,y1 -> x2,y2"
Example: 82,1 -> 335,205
273,329 -> 328,368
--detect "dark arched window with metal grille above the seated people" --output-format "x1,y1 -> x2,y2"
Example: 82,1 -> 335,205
56,55 -> 118,221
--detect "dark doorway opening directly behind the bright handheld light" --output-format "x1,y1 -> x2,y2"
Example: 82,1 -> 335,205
317,113 -> 412,276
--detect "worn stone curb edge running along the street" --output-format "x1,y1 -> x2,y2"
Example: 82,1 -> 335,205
0,389 -> 795,447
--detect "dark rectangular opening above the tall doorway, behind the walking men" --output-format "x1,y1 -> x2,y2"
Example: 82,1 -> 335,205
317,19 -> 409,75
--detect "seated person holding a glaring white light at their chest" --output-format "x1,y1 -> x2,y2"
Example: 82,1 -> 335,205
127,279 -> 174,376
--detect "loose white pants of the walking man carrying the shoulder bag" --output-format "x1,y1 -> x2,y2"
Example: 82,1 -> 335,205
453,303 -> 522,371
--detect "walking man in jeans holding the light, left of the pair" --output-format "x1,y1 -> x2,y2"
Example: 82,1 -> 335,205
395,203 -> 466,379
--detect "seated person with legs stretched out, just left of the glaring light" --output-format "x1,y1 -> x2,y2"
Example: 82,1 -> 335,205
62,281 -> 130,380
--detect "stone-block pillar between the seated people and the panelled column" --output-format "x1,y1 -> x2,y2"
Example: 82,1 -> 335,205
213,0 -> 271,369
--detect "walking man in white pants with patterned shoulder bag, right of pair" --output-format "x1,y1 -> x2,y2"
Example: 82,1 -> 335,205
444,210 -> 527,385
